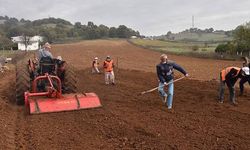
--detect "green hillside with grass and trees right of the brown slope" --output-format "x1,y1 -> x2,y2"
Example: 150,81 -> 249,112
130,23 -> 250,59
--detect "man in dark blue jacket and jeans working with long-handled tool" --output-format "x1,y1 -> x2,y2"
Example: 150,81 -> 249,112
156,54 -> 188,109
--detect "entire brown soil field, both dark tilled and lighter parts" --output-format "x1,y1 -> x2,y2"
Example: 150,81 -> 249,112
0,40 -> 250,150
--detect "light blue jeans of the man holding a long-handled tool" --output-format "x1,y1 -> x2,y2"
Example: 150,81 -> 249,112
158,80 -> 174,109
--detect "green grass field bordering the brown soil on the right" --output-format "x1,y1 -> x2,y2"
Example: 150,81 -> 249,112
129,39 -> 240,60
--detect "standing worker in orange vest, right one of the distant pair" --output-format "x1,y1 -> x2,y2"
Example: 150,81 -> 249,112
103,56 -> 115,85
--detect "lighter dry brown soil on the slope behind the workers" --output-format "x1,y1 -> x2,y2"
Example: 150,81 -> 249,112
53,40 -> 242,80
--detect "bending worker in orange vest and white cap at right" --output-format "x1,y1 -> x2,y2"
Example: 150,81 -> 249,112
219,67 -> 249,105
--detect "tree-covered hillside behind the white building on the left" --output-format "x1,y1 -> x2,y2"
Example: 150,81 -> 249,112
0,16 -> 140,49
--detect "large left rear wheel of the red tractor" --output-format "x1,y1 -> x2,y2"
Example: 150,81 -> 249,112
16,62 -> 30,105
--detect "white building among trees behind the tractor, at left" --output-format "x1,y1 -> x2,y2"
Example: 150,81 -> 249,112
11,36 -> 43,50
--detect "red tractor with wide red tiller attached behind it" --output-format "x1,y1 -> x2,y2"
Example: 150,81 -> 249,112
16,57 -> 101,114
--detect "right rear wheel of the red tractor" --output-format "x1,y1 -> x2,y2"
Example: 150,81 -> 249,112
64,64 -> 77,93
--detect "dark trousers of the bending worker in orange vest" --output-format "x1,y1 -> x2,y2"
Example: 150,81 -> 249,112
219,75 -> 235,103
